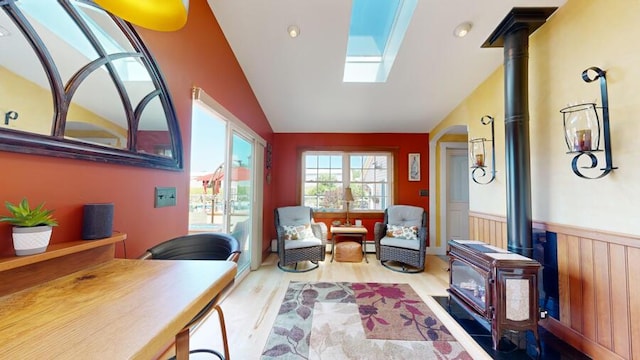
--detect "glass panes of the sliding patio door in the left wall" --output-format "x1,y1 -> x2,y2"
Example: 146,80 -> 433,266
189,103 -> 256,274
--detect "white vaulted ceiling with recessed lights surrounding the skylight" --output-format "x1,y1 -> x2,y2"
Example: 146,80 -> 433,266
207,0 -> 566,133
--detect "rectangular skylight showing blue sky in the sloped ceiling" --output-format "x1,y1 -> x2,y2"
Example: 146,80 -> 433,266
342,0 -> 418,82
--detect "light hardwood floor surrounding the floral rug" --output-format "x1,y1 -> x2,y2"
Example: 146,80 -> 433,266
179,254 -> 491,360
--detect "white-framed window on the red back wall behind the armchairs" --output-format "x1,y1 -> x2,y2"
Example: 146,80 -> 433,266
302,151 -> 393,212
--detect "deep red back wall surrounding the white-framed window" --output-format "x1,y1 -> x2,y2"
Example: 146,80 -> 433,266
265,133 -> 429,239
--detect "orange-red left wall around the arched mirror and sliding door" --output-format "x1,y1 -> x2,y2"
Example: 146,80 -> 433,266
0,0 -> 273,258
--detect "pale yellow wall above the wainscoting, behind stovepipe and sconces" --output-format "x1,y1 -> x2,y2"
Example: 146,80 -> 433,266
430,0 -> 640,234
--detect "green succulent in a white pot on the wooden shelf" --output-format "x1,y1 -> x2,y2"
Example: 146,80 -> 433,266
0,198 -> 58,256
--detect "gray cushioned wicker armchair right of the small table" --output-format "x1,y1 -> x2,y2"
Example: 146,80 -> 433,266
374,205 -> 427,273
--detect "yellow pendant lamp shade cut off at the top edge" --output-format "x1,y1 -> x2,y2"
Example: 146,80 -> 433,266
94,0 -> 189,31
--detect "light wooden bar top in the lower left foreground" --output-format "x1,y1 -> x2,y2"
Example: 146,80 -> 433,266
0,259 -> 236,360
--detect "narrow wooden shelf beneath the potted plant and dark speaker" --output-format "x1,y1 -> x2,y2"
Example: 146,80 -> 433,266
0,233 -> 127,271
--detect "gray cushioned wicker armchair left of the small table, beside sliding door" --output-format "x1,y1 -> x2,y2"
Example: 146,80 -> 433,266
274,206 -> 326,272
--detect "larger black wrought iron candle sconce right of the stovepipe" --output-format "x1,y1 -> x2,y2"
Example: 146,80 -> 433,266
560,66 -> 617,179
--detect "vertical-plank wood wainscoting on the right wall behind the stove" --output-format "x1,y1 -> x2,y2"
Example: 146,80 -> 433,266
469,212 -> 640,360
